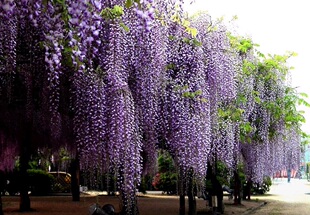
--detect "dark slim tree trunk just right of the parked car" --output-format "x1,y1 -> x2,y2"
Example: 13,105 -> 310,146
70,158 -> 80,202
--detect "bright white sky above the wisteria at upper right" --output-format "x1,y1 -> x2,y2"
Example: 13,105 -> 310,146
185,0 -> 310,134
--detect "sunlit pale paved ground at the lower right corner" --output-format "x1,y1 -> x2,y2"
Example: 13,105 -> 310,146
251,179 -> 310,215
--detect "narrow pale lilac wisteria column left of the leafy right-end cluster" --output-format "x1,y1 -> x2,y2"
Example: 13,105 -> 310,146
193,14 -> 242,169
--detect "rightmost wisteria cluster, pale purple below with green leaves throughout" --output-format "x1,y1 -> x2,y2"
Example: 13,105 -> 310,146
241,51 -> 300,183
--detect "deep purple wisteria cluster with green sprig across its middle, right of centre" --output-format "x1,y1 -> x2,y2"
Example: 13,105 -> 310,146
161,21 -> 210,185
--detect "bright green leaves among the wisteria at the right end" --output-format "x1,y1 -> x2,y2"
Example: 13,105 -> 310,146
240,50 -> 309,142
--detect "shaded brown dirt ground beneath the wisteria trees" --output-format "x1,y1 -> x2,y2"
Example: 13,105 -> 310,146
3,195 -> 261,215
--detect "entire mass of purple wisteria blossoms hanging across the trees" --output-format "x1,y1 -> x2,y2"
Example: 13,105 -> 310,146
0,0 -> 306,214
